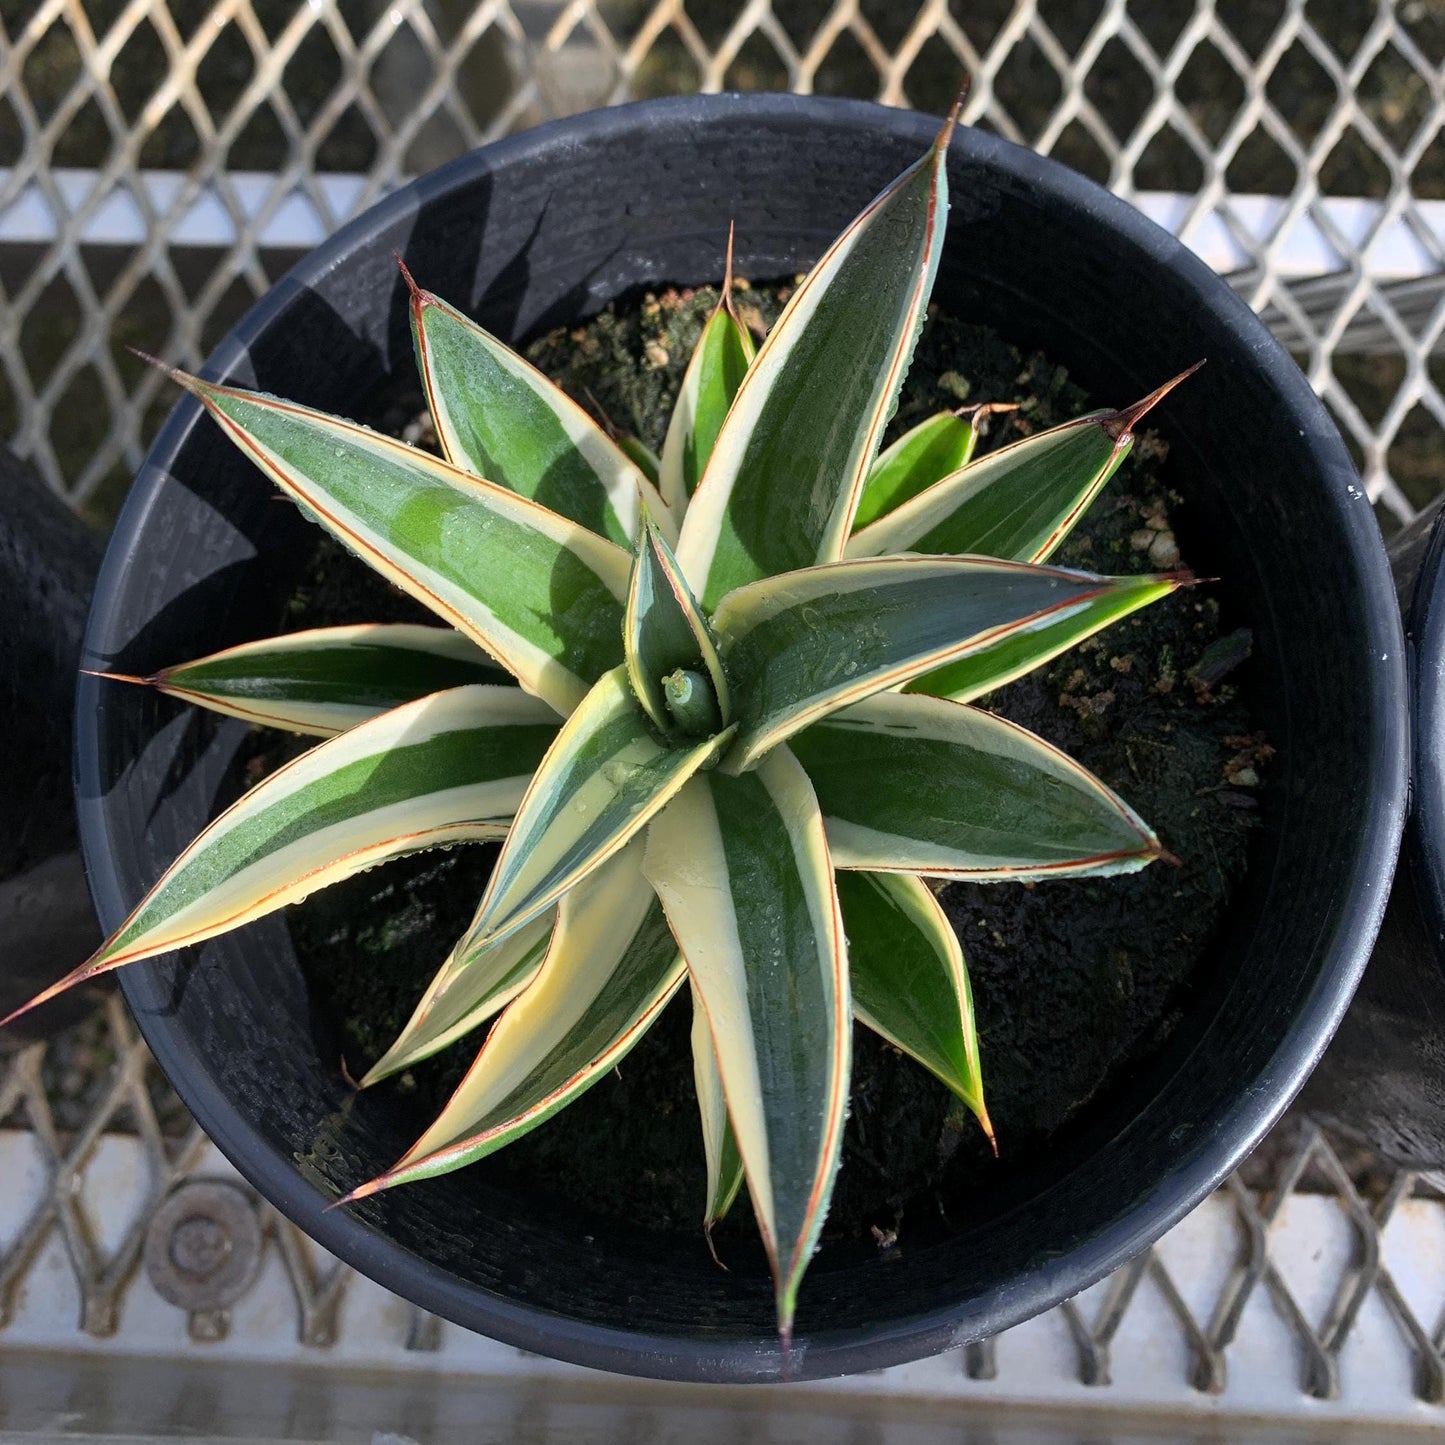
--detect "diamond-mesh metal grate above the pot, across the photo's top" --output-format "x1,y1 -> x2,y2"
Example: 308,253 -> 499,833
0,0 -> 1445,527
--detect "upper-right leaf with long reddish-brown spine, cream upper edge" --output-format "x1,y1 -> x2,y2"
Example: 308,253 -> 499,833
847,363 -> 1202,562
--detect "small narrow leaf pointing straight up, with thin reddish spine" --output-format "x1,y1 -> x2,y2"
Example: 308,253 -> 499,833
659,239 -> 757,517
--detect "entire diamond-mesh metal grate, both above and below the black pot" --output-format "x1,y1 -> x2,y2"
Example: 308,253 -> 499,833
0,0 -> 1445,1426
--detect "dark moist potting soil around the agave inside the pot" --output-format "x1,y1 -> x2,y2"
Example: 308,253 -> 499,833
278,286 -> 1270,1256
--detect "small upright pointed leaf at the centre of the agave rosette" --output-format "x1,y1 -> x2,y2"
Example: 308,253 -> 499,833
623,517 -> 731,734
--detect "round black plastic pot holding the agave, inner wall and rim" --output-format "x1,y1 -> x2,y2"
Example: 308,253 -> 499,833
77,95 -> 1406,1380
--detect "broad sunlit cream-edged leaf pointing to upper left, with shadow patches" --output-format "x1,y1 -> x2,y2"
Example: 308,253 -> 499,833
164,373 -> 631,715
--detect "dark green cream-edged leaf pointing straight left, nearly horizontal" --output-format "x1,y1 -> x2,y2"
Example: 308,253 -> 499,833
100,623 -> 512,737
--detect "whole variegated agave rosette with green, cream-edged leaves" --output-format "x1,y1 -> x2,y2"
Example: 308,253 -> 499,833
5,106 -> 1202,1338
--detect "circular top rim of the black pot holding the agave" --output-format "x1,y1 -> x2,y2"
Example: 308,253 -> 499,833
75,94 -> 1407,1381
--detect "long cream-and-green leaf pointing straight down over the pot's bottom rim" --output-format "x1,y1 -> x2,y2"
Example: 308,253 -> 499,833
644,749 -> 853,1340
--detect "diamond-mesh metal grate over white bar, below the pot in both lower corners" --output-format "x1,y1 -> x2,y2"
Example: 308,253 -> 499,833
0,997 -> 1445,1429
